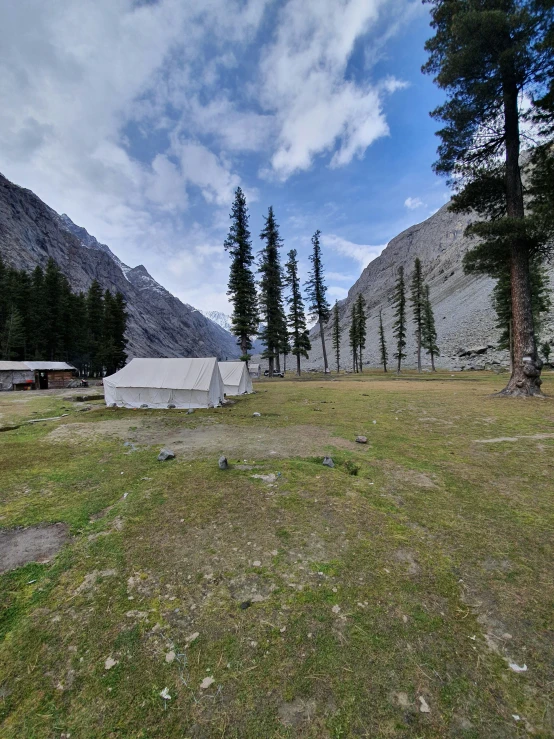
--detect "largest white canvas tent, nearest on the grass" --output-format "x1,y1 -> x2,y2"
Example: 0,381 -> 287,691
104,357 -> 224,408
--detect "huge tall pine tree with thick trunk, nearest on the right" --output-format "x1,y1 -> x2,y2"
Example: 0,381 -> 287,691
423,0 -> 554,395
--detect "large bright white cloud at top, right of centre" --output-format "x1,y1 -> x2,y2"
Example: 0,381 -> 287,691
261,0 -> 401,179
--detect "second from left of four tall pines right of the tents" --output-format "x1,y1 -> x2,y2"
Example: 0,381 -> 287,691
258,206 -> 284,377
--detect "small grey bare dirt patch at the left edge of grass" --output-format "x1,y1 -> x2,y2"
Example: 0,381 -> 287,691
0,523 -> 68,572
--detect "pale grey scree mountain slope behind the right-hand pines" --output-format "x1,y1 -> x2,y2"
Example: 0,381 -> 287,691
307,204 -> 554,369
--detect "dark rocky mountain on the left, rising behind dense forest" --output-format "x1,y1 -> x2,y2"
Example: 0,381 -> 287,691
0,175 -> 239,359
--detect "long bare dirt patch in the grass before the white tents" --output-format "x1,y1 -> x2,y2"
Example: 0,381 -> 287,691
46,419 -> 357,462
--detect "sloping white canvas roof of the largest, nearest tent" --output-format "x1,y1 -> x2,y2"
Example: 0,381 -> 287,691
104,357 -> 217,390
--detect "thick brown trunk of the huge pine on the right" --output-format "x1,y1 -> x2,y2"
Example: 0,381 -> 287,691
496,80 -> 542,396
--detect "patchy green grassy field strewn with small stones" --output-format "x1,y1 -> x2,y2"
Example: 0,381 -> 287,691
0,373 -> 554,739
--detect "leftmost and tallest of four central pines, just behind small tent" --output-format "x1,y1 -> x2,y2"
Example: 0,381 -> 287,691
224,187 -> 259,362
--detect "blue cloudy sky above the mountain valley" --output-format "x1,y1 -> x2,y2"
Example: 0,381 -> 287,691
0,0 -> 447,312
